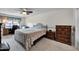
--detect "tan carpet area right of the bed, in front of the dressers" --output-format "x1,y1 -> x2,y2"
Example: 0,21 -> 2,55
30,38 -> 77,51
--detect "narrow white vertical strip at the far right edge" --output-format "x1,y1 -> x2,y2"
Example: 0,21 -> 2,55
75,9 -> 79,49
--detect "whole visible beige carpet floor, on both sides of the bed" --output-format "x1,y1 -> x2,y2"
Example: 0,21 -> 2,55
2,35 -> 76,51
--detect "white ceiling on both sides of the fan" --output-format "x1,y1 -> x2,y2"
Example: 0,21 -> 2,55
0,8 -> 72,17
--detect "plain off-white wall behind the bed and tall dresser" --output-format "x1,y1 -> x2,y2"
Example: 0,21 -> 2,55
26,8 -> 74,28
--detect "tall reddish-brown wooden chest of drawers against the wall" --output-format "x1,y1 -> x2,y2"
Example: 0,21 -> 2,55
56,25 -> 71,45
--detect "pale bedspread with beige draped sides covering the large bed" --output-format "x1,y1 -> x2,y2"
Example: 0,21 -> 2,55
15,28 -> 46,50
